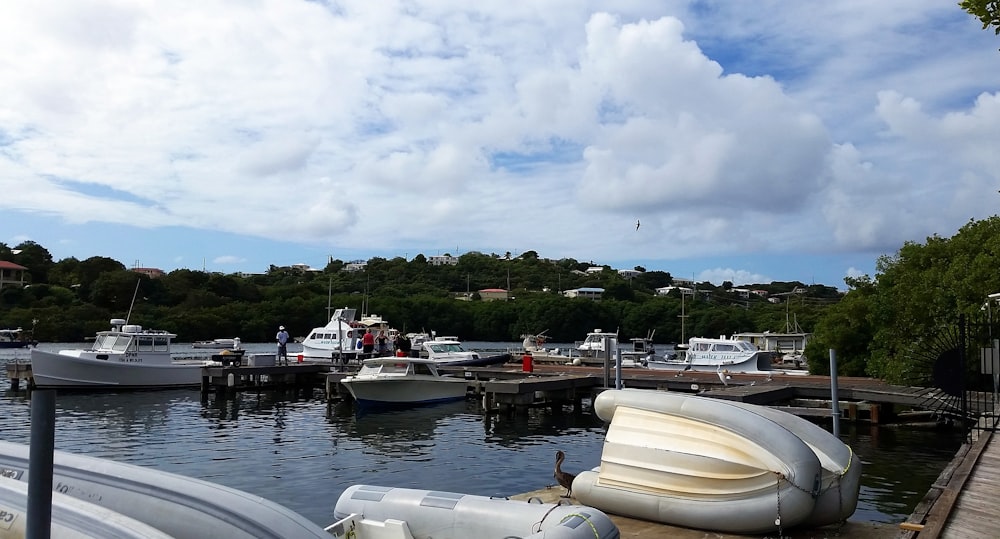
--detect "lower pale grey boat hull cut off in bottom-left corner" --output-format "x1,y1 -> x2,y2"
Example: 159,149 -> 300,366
0,476 -> 171,539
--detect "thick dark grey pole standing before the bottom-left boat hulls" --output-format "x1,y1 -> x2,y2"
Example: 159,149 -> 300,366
25,389 -> 56,539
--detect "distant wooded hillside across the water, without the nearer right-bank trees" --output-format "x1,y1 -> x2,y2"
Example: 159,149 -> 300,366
0,242 -> 840,354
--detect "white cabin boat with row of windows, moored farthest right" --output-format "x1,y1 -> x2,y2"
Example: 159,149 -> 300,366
646,336 -> 773,373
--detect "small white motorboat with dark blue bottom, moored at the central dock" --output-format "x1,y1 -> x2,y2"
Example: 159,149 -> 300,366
340,357 -> 467,406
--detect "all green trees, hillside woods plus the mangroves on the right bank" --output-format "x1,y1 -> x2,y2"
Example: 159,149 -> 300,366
7,211 -> 1000,385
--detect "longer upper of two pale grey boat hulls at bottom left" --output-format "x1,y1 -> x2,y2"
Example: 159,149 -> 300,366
0,441 -> 329,539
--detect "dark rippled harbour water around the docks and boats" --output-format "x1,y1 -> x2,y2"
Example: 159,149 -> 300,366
0,343 -> 963,525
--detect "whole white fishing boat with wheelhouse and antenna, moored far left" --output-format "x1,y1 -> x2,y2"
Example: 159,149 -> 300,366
31,318 -> 215,389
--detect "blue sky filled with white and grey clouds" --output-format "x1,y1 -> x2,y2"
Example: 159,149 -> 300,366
0,0 -> 1000,289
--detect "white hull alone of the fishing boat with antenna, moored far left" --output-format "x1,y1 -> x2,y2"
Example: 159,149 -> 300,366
31,348 -> 212,389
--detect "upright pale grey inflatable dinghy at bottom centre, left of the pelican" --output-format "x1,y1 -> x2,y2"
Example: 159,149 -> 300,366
327,485 -> 619,539
